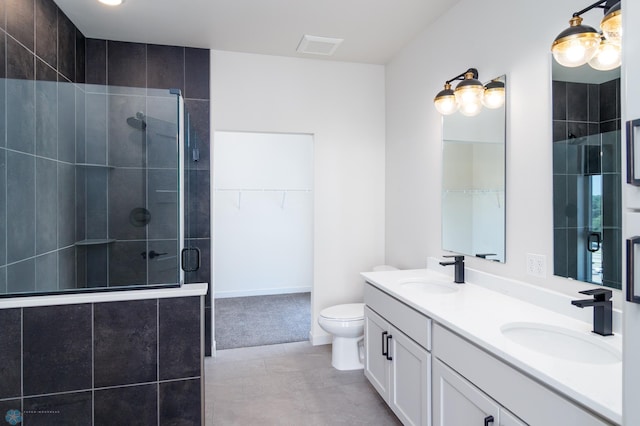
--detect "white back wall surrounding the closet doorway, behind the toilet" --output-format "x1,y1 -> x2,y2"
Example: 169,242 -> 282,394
211,50 -> 385,343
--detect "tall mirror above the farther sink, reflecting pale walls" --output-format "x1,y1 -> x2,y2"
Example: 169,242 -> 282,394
442,75 -> 506,262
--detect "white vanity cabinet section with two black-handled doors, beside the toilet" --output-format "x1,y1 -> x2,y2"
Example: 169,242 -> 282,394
364,284 -> 431,426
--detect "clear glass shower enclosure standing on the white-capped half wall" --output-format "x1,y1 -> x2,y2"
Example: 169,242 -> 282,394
0,79 -> 199,295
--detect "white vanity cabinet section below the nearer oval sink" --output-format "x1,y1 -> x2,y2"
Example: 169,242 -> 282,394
432,324 -> 610,426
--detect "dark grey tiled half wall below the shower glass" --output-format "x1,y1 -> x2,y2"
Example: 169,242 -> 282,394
0,297 -> 204,425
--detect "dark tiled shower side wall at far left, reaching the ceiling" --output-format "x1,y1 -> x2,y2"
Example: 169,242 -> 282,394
0,0 -> 85,293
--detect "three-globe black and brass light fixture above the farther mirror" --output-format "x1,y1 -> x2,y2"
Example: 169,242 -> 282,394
433,68 -> 504,117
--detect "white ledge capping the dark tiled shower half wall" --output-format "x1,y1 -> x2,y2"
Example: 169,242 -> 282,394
0,283 -> 209,309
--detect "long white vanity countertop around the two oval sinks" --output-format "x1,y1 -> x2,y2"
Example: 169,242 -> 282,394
362,269 -> 622,424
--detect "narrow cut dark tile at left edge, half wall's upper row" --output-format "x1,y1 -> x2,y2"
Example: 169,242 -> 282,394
0,309 -> 22,400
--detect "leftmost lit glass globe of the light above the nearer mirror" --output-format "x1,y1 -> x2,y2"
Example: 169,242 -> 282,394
551,16 -> 600,67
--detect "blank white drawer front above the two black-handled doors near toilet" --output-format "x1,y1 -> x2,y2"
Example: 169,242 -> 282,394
364,283 -> 431,351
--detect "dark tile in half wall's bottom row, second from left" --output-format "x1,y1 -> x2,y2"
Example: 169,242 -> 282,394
23,391 -> 93,426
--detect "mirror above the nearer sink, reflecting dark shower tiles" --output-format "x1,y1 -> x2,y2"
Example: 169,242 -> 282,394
551,58 -> 622,289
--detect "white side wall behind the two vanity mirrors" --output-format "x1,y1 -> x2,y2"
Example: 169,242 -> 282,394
385,0 -> 619,301
